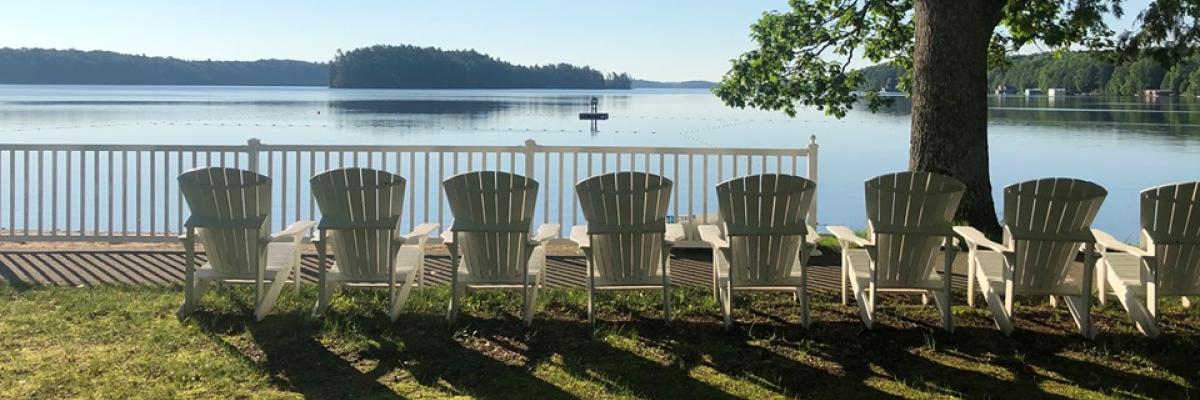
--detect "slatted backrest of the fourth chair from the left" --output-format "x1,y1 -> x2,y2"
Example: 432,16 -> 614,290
575,172 -> 672,283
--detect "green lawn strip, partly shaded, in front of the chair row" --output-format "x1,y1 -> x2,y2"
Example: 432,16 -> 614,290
0,283 -> 1200,399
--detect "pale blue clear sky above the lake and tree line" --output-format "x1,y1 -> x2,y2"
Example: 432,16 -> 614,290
0,0 -> 1150,80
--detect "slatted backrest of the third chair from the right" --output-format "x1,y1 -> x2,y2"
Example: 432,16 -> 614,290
865,172 -> 966,287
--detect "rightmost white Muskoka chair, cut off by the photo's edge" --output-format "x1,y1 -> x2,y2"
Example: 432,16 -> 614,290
1092,181 -> 1200,338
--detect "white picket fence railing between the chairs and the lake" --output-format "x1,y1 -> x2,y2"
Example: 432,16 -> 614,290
0,137 -> 817,241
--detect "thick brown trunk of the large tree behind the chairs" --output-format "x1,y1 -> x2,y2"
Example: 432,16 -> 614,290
908,0 -> 1002,234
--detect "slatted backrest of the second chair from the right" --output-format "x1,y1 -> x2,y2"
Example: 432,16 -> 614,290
1004,178 -> 1108,294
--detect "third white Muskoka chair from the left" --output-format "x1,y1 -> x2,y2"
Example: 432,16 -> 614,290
442,171 -> 559,326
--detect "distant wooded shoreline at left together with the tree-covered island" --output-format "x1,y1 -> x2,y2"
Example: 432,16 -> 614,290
0,46 -> 634,89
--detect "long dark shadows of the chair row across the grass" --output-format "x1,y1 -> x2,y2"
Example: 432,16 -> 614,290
175,284 -> 1200,399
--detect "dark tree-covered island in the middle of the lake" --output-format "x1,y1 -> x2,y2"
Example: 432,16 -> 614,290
329,46 -> 632,89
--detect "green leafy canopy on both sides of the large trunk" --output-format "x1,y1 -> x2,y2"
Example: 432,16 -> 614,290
714,0 -> 1200,117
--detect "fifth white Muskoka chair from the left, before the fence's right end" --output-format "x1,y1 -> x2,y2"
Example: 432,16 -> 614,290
698,174 -> 820,328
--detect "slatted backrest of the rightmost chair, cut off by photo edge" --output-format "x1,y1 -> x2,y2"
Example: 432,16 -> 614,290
1141,181 -> 1200,295
